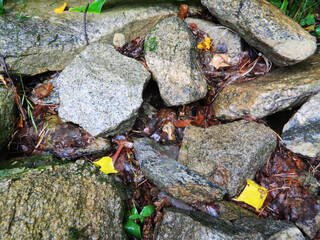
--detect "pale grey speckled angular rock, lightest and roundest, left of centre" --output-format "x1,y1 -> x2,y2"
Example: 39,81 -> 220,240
57,43 -> 150,137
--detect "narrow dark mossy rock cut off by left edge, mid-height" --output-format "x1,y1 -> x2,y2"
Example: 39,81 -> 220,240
0,86 -> 16,150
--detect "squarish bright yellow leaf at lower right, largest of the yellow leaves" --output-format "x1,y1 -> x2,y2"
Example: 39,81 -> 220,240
233,180 -> 267,211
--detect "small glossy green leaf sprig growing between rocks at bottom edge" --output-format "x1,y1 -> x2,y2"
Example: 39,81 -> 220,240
124,205 -> 155,238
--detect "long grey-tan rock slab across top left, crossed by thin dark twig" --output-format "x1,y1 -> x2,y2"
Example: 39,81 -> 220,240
0,0 -> 177,75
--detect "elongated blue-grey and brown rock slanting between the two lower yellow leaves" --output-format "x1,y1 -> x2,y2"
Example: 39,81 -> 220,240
134,138 -> 225,204
